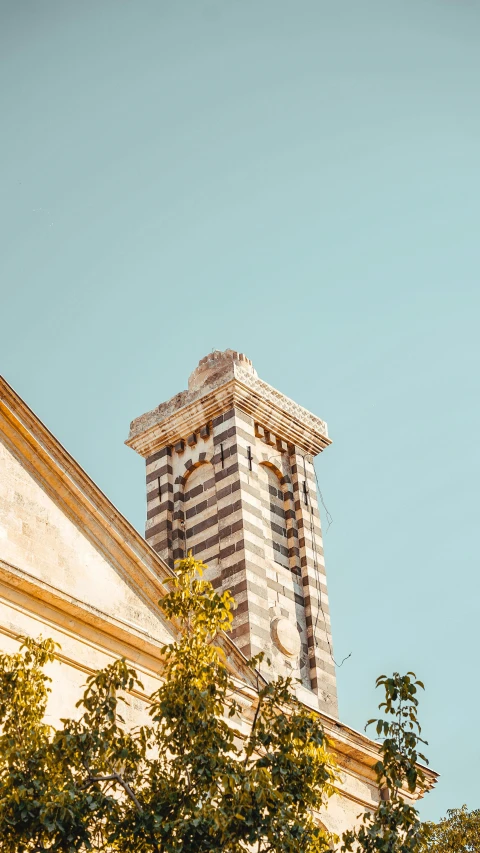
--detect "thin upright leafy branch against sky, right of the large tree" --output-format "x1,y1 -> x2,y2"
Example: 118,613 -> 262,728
341,672 -> 428,853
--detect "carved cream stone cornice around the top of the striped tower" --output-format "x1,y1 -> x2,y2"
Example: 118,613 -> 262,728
125,361 -> 331,457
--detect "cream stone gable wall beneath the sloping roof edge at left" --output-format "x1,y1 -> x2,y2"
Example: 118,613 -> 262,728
0,424 -> 173,724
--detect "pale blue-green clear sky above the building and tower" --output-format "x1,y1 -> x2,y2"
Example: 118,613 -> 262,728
0,0 -> 480,818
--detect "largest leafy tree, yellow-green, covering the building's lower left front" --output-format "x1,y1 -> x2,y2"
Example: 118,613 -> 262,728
0,557 -> 335,853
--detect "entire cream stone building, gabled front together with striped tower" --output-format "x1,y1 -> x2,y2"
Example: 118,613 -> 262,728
0,351 -> 435,833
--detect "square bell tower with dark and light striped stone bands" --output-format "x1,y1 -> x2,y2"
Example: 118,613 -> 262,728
126,350 -> 338,717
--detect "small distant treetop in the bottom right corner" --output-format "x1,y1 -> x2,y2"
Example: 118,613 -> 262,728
420,806 -> 480,853
